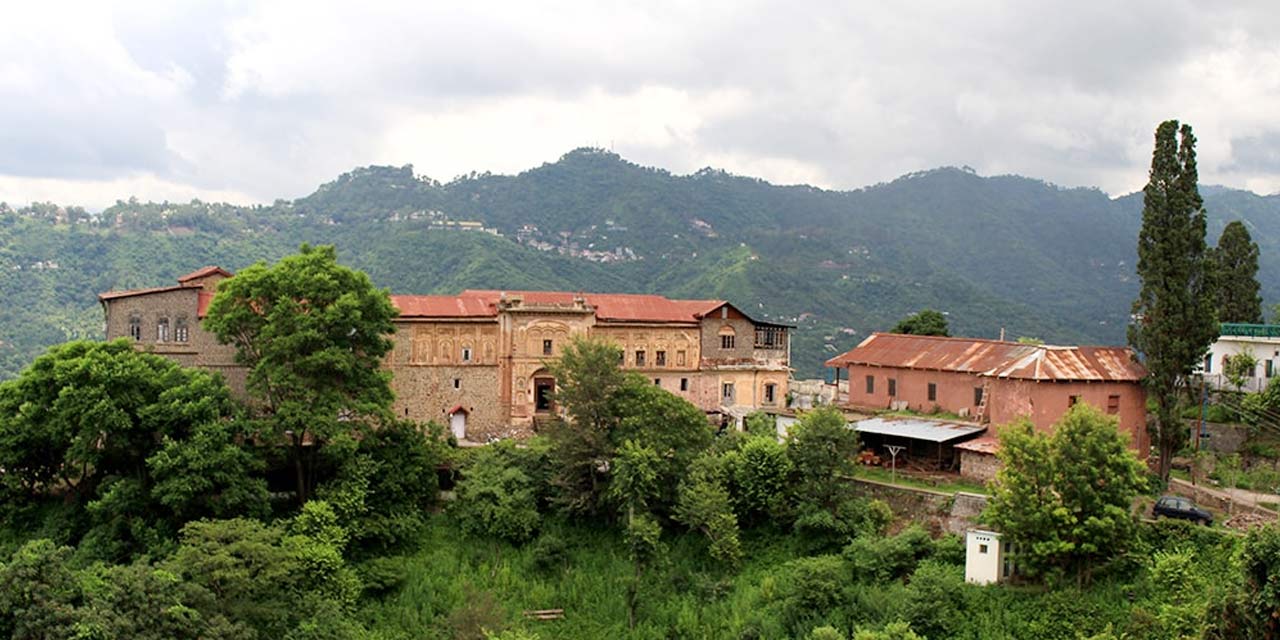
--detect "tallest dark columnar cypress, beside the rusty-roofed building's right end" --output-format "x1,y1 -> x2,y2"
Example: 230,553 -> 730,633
1129,120 -> 1217,480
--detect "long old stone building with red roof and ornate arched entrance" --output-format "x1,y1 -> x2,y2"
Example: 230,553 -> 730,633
99,268 -> 791,440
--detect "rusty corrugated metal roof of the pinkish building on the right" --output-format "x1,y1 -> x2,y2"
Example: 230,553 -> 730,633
827,333 -> 1147,381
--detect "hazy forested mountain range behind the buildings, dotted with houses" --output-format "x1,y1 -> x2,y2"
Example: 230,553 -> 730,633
0,150 -> 1280,378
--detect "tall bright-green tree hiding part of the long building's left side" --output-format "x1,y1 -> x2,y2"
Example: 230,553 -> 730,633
204,244 -> 397,502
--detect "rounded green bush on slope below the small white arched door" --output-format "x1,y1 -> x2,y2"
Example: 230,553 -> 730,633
453,440 -> 541,544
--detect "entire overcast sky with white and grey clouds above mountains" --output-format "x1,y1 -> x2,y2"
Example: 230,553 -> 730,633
0,0 -> 1280,209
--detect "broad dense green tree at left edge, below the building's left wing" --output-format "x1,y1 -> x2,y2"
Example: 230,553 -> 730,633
0,339 -> 232,499
